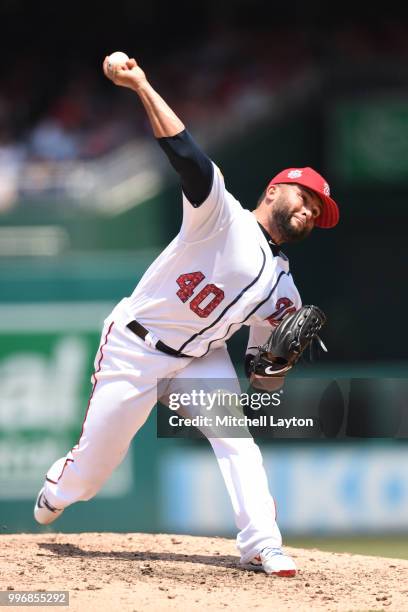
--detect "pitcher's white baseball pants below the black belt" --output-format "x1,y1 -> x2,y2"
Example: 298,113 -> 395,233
45,313 -> 282,563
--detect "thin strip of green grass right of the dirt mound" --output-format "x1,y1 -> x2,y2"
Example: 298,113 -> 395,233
284,534 -> 408,559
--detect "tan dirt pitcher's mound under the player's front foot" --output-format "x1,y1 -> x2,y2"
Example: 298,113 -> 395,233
0,533 -> 408,612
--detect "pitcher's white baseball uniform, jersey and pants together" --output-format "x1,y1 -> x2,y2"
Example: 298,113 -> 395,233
41,164 -> 290,563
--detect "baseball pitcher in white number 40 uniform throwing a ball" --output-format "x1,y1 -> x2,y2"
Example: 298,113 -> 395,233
34,58 -> 339,576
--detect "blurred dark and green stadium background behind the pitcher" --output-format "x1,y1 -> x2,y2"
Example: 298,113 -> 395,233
0,0 -> 408,558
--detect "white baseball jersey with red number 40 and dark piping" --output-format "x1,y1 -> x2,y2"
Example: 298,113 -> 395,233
113,165 -> 301,357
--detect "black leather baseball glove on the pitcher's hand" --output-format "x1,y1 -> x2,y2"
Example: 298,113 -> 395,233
249,306 -> 327,377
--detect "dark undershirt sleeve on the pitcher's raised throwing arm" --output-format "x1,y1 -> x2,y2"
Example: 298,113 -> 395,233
157,130 -> 214,207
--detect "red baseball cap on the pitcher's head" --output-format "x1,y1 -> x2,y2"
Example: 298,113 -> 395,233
268,167 -> 340,228
